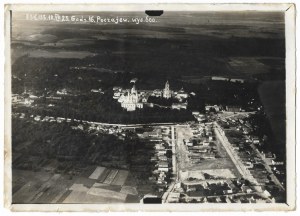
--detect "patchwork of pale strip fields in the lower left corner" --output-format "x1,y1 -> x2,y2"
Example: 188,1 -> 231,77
13,167 -> 139,203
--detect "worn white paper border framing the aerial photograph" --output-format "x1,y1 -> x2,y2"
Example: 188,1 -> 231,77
4,3 -> 296,212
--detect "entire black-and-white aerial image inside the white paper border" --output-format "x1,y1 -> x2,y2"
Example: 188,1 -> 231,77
10,11 -> 287,205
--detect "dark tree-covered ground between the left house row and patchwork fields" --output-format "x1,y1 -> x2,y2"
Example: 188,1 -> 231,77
12,118 -> 153,184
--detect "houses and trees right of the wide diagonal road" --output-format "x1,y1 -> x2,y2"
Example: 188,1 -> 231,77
218,116 -> 285,199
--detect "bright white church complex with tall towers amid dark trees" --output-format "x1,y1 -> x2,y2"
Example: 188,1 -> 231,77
113,80 -> 189,111
